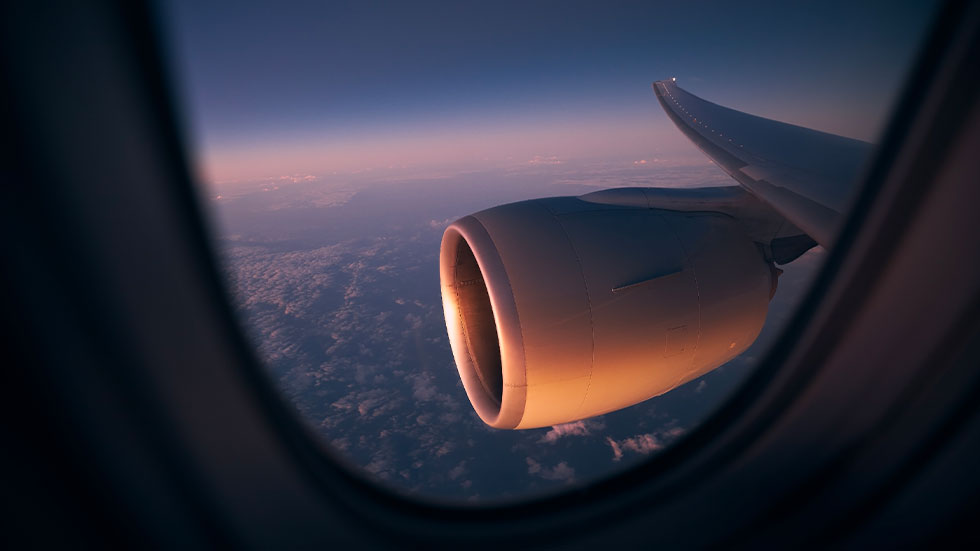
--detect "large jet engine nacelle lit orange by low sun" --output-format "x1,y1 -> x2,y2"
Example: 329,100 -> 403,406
440,196 -> 774,429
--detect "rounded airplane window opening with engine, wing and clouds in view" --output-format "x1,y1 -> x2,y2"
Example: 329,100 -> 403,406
159,0 -> 933,502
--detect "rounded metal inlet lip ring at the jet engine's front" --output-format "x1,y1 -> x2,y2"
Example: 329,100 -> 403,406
439,216 -> 527,429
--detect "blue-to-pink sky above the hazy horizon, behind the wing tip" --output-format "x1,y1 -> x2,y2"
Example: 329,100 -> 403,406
159,0 -> 934,186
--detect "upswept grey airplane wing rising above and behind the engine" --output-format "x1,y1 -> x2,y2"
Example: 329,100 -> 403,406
653,79 -> 872,247
